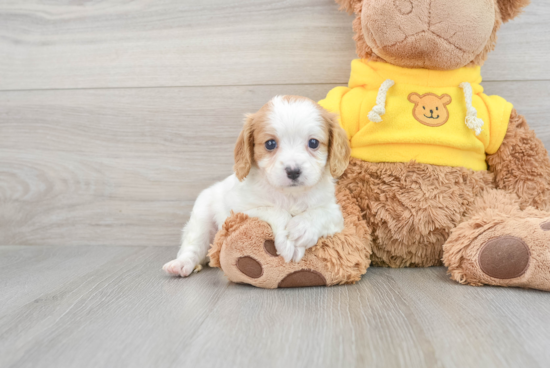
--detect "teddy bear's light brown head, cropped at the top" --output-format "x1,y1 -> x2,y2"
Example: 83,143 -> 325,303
336,0 -> 530,70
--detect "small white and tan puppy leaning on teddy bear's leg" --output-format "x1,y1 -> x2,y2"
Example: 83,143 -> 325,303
163,96 -> 350,277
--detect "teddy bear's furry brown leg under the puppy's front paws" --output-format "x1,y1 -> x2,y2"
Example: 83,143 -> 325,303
209,189 -> 371,289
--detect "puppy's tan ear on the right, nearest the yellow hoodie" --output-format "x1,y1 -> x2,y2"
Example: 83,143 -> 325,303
323,110 -> 351,178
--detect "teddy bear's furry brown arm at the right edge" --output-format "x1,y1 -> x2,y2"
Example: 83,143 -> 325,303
487,109 -> 550,209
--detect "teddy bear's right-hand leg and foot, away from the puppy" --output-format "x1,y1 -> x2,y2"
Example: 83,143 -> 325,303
443,190 -> 550,291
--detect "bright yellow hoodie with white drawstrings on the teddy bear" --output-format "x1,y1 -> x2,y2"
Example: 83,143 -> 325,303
319,60 -> 513,170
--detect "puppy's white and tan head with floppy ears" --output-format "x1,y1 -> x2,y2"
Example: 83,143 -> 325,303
234,96 -> 350,188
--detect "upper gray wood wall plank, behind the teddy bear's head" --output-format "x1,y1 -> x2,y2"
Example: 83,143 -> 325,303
0,0 -> 550,90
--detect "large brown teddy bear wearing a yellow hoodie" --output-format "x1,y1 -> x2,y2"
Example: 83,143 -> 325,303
209,0 -> 550,290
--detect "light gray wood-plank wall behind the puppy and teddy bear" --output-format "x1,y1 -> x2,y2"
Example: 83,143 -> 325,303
0,0 -> 550,246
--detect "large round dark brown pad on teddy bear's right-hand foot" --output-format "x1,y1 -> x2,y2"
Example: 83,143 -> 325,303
479,236 -> 531,280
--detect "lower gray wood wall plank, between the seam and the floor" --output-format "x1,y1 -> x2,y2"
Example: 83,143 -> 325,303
0,82 -> 550,246
